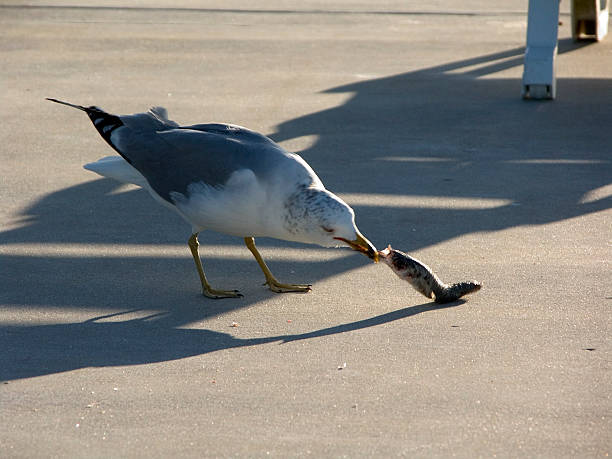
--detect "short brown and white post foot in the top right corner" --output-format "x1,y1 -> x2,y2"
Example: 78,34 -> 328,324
572,0 -> 609,41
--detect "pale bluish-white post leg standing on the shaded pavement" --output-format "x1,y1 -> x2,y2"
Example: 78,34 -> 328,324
522,0 -> 559,99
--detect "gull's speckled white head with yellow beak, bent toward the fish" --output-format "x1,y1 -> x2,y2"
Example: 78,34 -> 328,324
284,187 -> 378,262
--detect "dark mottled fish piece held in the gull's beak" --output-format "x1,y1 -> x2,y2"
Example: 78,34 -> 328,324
378,245 -> 482,303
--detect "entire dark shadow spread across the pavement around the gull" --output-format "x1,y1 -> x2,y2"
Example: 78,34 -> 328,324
0,41 -> 612,379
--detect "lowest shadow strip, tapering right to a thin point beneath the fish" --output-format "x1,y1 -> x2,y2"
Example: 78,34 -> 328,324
0,301 -> 454,381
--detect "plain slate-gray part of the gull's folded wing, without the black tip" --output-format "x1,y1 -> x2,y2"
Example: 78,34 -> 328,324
111,117 -> 307,202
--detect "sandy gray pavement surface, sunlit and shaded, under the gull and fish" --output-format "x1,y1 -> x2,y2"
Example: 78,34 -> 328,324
0,0 -> 612,458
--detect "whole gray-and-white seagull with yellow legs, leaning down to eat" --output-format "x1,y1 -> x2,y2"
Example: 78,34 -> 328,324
47,98 -> 378,299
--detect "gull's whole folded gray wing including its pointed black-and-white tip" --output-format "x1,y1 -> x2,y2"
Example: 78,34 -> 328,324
48,98 -> 320,203
